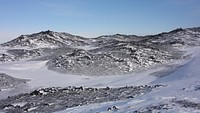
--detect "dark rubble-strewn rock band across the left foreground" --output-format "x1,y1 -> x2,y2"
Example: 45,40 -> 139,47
0,85 -> 161,112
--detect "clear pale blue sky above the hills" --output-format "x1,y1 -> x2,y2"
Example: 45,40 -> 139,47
0,0 -> 200,42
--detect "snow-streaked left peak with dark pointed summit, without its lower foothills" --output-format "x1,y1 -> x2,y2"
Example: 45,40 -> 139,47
1,30 -> 88,49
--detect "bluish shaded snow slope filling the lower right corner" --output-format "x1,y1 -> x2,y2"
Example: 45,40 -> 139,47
56,47 -> 200,113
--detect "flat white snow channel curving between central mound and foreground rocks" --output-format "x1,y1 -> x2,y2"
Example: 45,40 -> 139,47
0,57 -> 174,88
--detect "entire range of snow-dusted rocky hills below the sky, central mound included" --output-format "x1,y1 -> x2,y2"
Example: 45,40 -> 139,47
0,27 -> 200,76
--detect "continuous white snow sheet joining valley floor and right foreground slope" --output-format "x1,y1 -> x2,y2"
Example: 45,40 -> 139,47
0,47 -> 200,113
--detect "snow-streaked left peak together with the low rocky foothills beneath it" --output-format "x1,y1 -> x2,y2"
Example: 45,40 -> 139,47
0,31 -> 89,62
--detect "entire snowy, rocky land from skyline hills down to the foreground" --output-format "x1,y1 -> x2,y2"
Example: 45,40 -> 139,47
0,27 -> 200,113
